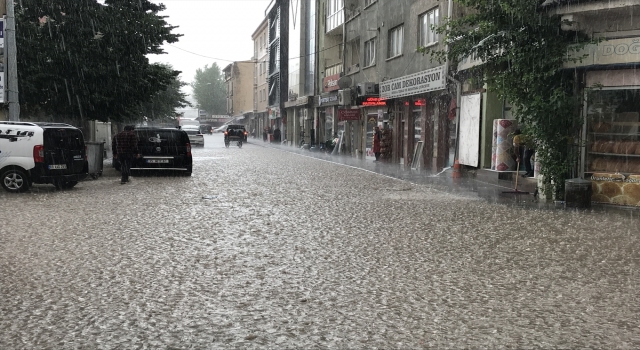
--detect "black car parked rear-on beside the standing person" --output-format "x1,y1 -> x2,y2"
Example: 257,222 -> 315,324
113,127 -> 193,175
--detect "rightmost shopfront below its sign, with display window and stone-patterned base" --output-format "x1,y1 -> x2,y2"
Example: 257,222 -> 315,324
583,69 -> 640,206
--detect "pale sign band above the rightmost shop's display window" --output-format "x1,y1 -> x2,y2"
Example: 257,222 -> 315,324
564,37 -> 640,68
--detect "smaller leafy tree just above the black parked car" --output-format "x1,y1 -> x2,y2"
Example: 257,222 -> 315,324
131,65 -> 191,122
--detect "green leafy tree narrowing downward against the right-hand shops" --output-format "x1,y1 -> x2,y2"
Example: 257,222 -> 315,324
420,0 -> 591,196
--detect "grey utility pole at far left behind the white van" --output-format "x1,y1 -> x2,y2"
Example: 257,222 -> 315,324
5,0 -> 20,121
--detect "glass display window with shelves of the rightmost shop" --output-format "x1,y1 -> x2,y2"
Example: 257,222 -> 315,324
586,89 -> 640,175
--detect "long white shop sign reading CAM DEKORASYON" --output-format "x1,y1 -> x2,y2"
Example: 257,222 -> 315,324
380,66 -> 445,99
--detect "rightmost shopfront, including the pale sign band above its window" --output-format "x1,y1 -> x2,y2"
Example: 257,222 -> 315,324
567,37 -> 640,206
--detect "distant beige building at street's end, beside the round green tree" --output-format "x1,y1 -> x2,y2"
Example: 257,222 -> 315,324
223,60 -> 254,123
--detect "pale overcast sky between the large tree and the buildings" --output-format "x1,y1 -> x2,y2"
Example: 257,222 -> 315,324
149,0 -> 270,93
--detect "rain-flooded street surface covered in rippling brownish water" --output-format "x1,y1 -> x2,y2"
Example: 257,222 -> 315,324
0,135 -> 640,349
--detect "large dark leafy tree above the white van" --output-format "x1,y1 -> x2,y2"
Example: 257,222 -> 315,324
16,0 -> 180,121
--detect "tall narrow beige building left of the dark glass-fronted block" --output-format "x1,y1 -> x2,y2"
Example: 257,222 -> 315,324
250,18 -> 271,137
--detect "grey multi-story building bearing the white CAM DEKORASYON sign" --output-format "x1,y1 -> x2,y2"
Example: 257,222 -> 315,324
342,0 -> 456,170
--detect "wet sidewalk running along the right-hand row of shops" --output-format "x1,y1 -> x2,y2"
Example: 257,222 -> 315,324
249,139 -> 640,217
